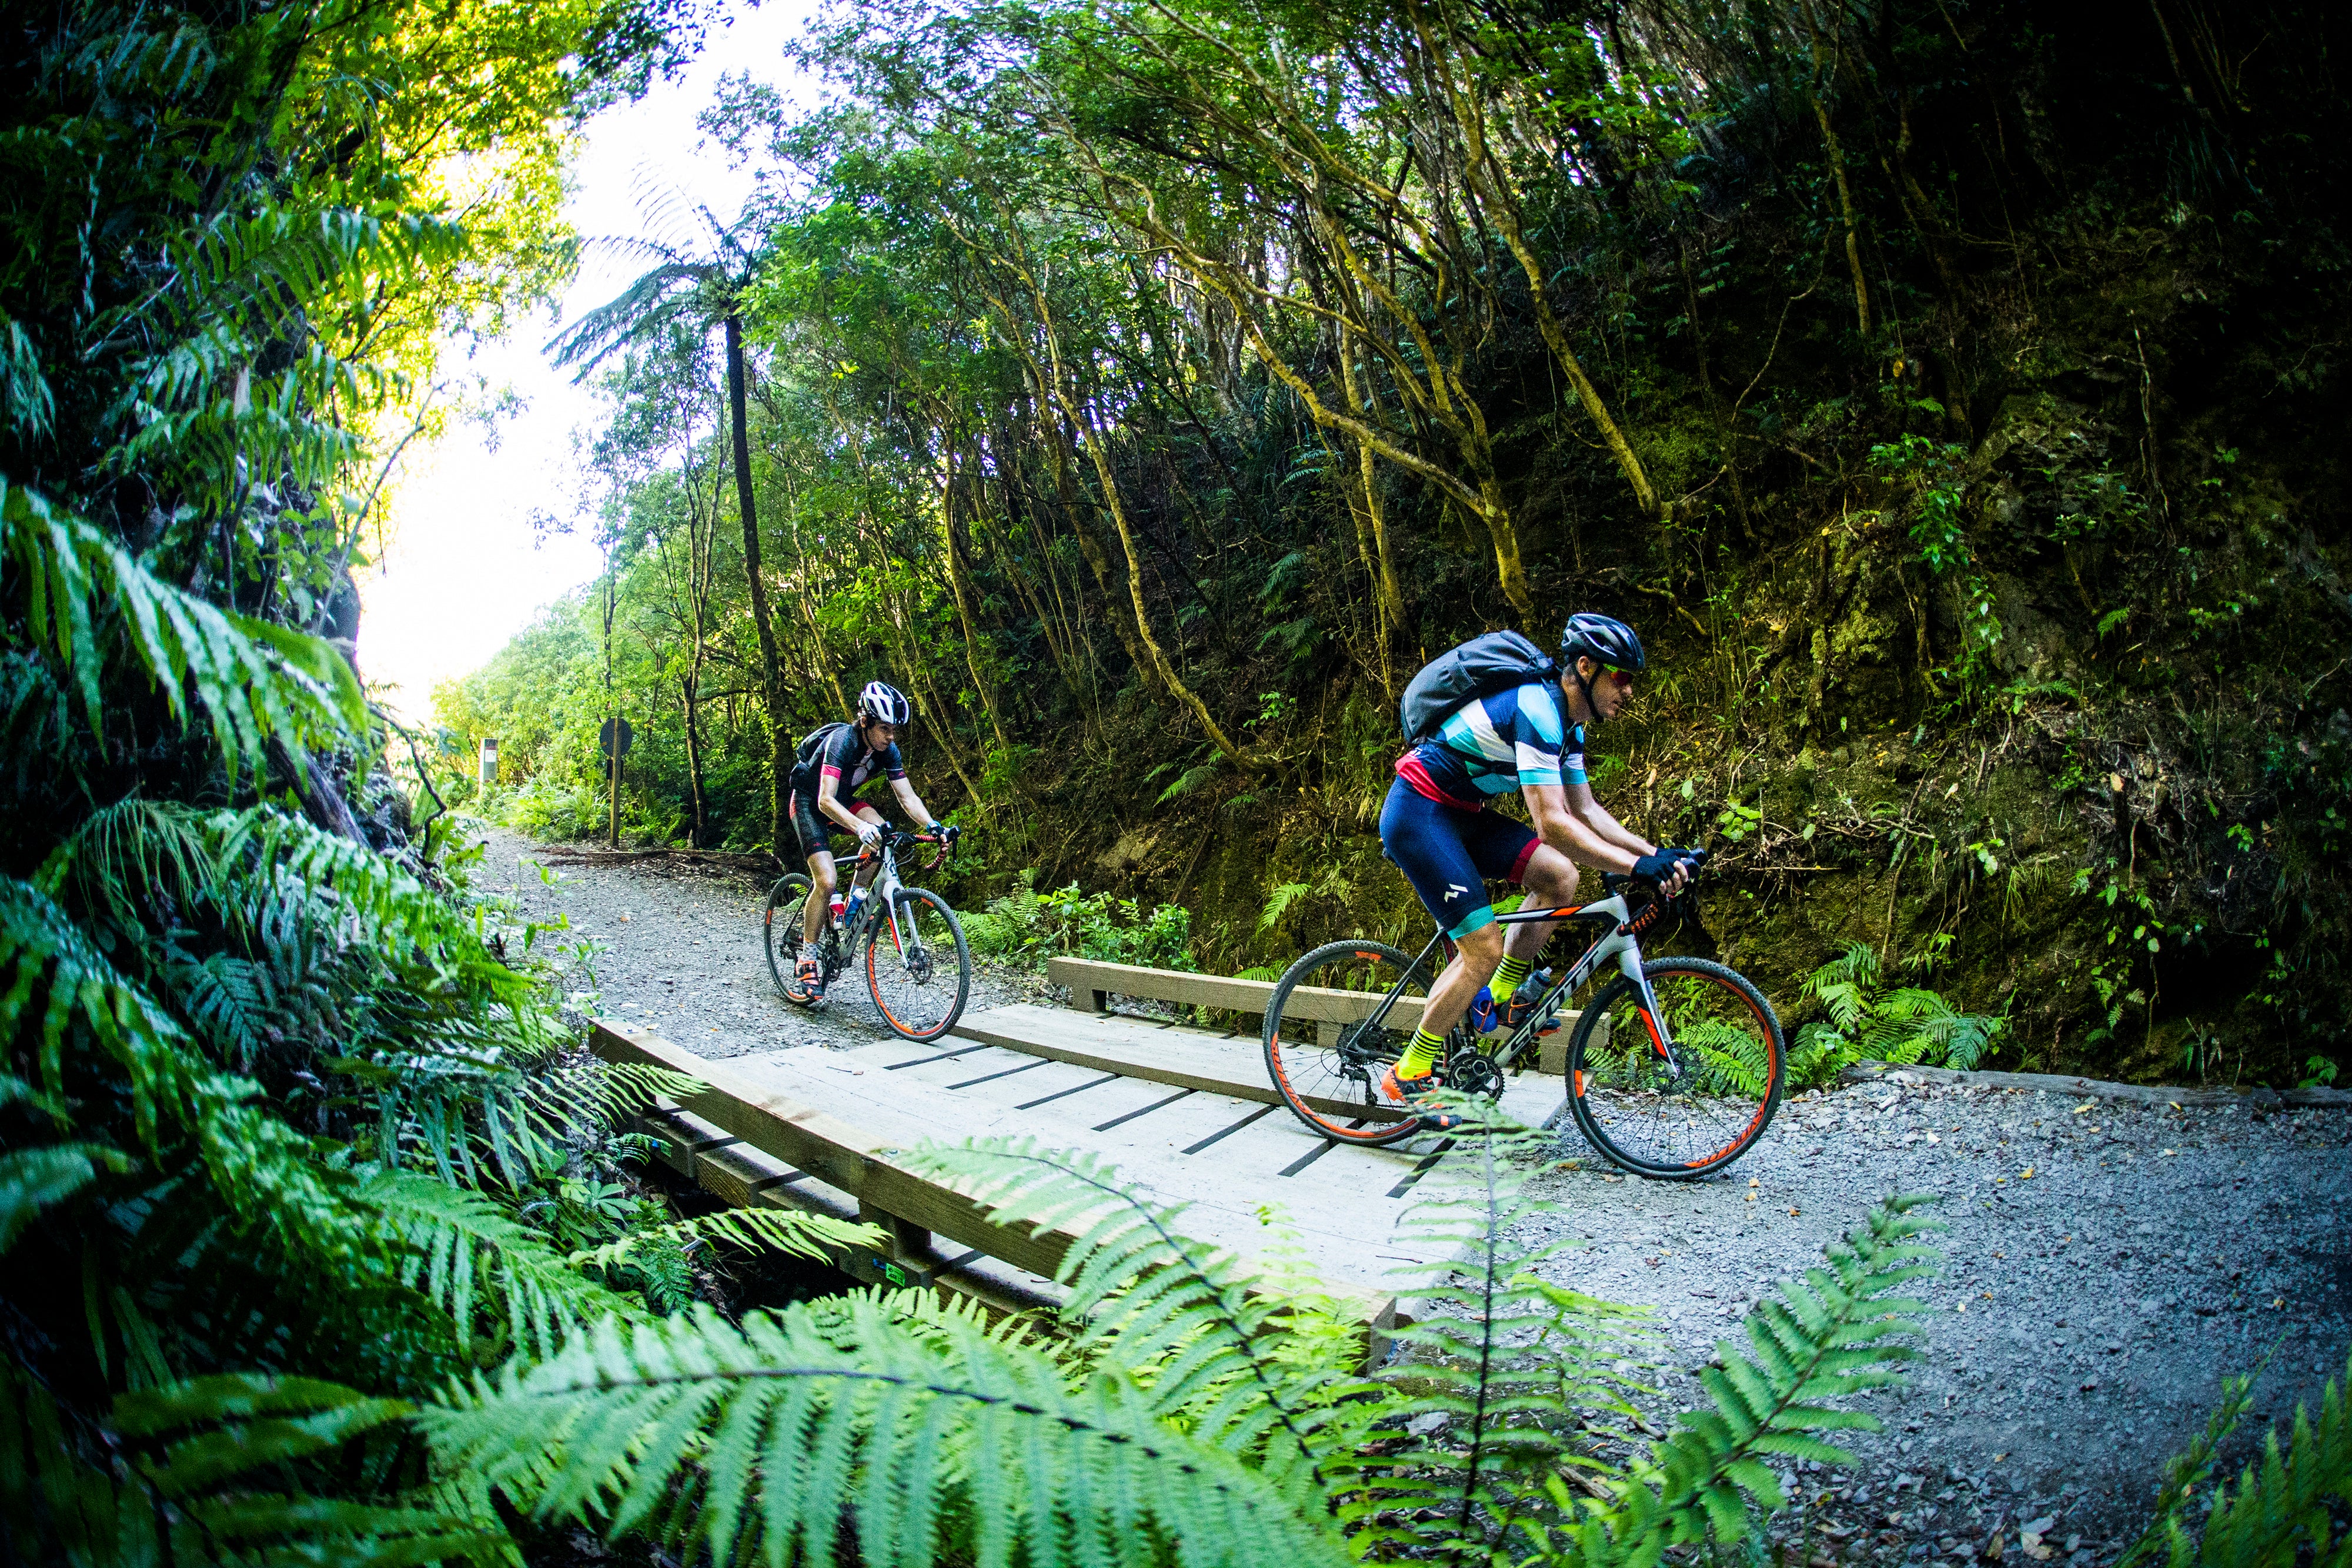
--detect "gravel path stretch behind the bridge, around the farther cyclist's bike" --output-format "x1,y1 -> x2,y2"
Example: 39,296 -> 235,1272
456,827 -> 1042,1058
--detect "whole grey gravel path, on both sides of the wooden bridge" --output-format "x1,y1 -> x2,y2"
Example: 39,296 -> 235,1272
449,830 -> 2352,1568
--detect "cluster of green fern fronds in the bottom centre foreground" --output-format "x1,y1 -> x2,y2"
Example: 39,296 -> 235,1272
419,1102 -> 1931,1568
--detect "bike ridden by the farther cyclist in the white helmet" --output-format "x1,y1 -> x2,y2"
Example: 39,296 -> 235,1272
760,830 -> 971,1039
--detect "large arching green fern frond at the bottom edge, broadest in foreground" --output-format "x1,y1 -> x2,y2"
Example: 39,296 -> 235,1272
419,1298 -> 1348,1568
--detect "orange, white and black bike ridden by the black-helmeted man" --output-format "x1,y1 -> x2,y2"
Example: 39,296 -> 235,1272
1263,855 -> 1788,1180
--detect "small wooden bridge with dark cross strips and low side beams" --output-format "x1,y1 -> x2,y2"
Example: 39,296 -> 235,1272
593,959 -> 1573,1338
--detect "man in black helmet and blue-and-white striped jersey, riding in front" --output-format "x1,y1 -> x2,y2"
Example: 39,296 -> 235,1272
1378,614 -> 1686,1126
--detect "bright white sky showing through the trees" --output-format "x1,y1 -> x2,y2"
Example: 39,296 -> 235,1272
360,0 -> 818,724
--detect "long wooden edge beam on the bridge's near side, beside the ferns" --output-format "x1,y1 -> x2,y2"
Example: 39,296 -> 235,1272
590,1022 -> 1397,1333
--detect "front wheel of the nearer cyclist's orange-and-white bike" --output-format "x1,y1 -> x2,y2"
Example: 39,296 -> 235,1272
1566,959 -> 1788,1180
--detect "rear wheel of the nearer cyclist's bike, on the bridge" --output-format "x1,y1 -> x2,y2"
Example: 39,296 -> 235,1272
1263,942 -> 1435,1145
